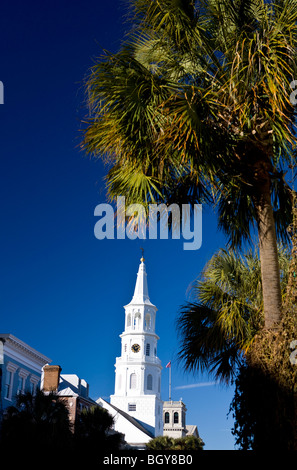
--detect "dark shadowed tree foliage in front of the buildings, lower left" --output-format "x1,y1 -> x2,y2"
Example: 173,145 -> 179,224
0,391 -> 126,462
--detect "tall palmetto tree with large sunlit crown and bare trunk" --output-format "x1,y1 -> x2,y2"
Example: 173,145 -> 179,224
82,0 -> 297,328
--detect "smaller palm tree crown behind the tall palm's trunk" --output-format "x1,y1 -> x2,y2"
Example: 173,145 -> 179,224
176,247 -> 291,383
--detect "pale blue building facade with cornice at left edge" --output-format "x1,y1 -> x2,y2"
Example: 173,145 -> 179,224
0,333 -> 51,414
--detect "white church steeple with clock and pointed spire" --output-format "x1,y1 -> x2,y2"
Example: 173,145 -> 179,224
110,256 -> 163,440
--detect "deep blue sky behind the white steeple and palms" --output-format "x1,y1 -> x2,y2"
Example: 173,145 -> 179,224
0,0 -> 234,450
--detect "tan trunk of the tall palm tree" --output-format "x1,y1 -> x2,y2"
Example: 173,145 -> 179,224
254,158 -> 282,329
